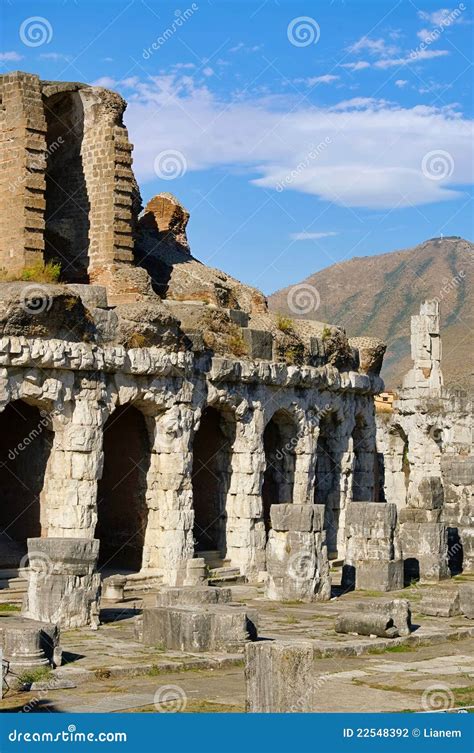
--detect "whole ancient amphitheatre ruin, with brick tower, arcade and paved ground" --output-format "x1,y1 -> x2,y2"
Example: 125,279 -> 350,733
0,72 -> 474,712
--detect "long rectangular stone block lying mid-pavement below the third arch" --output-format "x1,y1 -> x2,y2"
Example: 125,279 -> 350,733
143,604 -> 257,652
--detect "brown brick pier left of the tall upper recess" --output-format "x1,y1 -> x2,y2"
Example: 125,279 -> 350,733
0,71 -> 46,273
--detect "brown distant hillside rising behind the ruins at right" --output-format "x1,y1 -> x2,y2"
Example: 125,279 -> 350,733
269,237 -> 474,390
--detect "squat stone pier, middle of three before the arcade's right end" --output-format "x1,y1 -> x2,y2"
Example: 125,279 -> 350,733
342,502 -> 403,591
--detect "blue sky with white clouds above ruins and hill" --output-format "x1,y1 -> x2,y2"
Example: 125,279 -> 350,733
0,0 -> 474,293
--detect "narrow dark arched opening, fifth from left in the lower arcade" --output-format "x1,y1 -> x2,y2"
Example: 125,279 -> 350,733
314,411 -> 341,559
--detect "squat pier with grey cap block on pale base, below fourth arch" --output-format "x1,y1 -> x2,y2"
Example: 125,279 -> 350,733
265,504 -> 331,601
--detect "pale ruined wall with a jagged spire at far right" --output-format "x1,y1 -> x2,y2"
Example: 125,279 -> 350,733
377,300 -> 474,583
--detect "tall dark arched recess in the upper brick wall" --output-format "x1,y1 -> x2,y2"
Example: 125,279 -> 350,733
44,91 -> 90,283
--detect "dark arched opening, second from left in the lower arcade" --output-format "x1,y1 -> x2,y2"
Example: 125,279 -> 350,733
95,405 -> 151,571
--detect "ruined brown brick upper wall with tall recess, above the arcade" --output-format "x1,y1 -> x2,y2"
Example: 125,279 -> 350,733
0,72 -> 148,302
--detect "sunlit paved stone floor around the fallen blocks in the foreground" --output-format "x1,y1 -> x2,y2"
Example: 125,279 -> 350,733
0,581 -> 474,712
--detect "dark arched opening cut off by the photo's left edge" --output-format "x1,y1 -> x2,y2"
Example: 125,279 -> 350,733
0,400 -> 53,567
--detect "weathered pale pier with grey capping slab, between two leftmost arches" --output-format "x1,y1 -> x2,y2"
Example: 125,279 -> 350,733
22,538 -> 100,629
